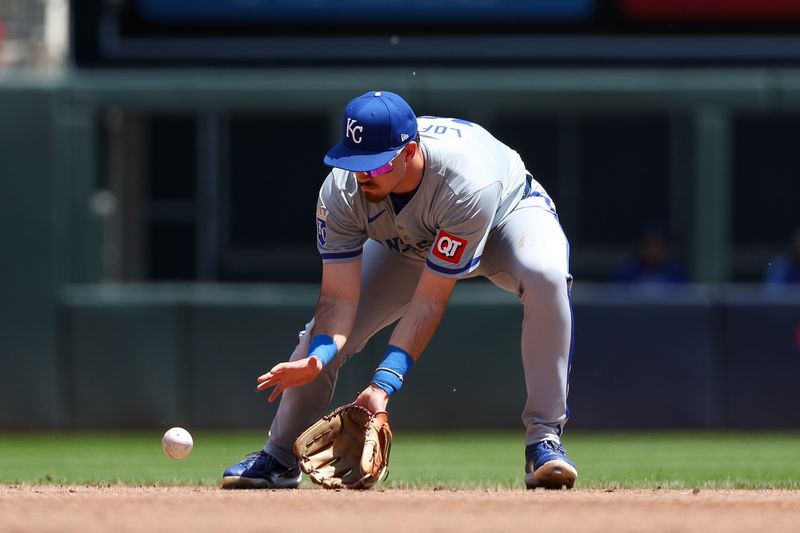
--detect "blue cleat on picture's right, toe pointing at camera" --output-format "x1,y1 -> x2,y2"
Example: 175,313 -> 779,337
525,440 -> 578,490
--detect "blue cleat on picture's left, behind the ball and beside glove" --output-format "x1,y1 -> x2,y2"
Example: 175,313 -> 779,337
222,450 -> 301,489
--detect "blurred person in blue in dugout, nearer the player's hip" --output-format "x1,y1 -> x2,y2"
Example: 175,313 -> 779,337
613,219 -> 689,285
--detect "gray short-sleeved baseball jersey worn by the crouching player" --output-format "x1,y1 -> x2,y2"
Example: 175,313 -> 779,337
317,117 -> 555,278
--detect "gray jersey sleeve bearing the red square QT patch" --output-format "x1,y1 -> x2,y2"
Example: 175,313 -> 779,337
426,183 -> 501,278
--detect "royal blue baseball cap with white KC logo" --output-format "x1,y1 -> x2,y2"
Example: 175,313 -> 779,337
324,91 -> 417,172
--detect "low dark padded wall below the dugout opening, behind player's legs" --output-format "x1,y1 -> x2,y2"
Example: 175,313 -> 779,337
47,282 -> 800,429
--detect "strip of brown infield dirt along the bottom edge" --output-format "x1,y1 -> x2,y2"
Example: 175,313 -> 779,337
0,486 -> 800,533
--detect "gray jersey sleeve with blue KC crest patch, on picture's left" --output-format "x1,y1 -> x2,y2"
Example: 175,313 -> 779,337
316,172 -> 367,263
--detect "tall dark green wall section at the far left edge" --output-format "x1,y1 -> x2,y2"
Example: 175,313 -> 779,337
0,87 -> 59,426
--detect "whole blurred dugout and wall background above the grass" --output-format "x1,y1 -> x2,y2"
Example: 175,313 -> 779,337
0,0 -> 800,428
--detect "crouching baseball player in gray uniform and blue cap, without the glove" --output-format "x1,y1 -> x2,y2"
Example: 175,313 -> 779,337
223,91 -> 578,488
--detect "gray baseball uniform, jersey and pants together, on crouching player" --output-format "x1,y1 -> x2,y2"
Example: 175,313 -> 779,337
264,117 -> 572,465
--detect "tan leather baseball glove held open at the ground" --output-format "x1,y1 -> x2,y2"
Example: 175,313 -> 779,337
294,404 -> 392,489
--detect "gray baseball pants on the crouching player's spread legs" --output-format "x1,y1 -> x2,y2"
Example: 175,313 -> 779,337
264,204 -> 572,465
